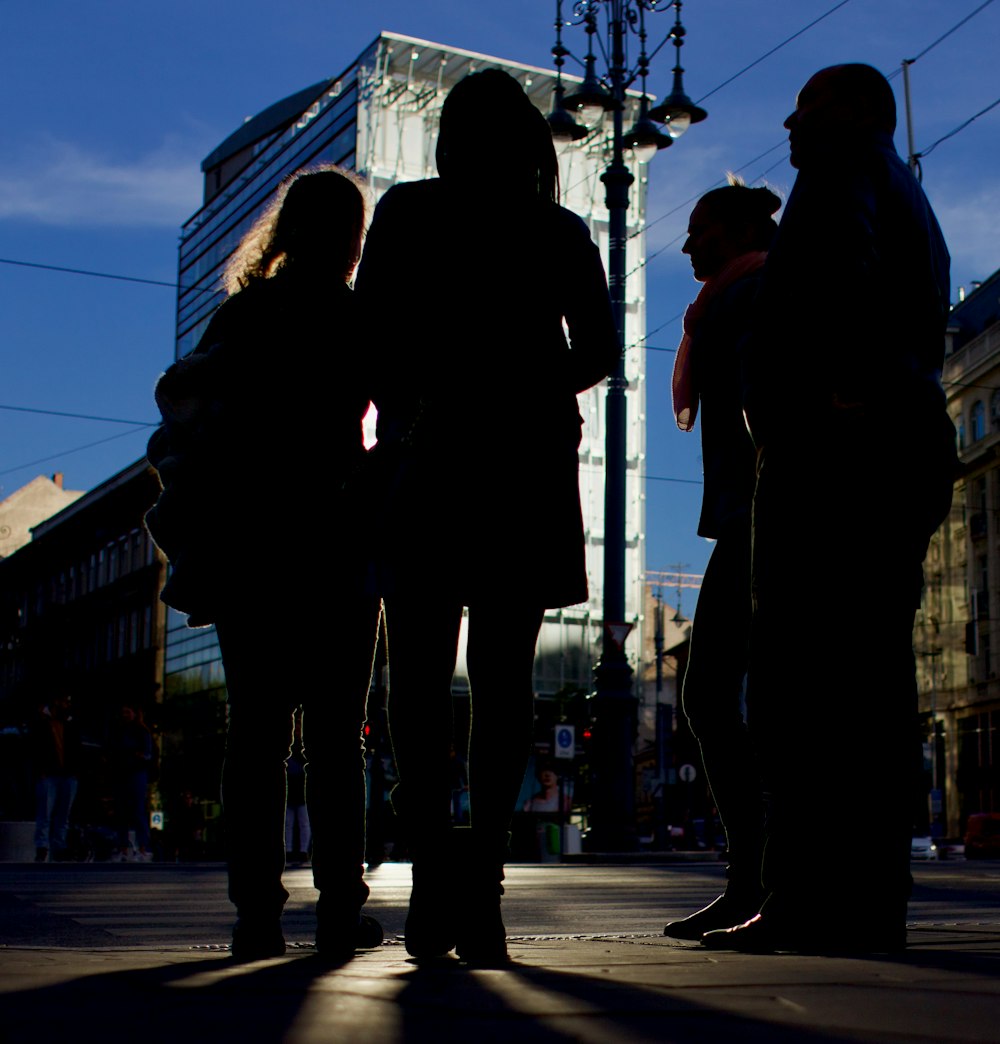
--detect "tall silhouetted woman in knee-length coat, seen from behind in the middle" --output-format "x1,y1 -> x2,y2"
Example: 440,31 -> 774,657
358,70 -> 618,964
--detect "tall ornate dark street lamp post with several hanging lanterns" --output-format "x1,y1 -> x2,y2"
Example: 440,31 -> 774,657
549,0 -> 707,851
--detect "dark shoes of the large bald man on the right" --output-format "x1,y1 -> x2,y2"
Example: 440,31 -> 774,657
701,914 -> 906,956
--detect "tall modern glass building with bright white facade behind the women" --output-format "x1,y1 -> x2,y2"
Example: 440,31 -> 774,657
166,32 -> 646,734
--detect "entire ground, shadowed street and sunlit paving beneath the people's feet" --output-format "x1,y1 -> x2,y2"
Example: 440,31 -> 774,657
0,863 -> 1000,1044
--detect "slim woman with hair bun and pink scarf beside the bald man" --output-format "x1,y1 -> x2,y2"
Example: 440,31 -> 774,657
664,180 -> 781,940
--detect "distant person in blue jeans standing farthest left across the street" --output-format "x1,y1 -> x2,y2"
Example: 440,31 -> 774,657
29,690 -> 82,862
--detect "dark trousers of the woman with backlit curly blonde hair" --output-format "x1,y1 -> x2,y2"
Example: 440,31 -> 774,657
216,596 -> 379,917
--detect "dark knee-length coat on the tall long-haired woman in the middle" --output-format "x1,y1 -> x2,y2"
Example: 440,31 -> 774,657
357,180 -> 618,607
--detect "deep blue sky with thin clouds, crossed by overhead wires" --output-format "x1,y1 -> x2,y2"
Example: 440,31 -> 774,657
0,0 -> 1000,607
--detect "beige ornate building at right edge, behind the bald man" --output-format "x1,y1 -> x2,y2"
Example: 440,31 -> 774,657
913,271 -> 1000,836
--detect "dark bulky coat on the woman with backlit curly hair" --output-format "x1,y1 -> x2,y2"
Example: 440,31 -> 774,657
146,269 -> 370,626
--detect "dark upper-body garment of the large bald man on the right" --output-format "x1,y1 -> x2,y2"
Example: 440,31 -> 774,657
744,135 -> 950,450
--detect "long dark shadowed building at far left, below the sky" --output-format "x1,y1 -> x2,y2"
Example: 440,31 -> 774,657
0,460 -> 166,825
